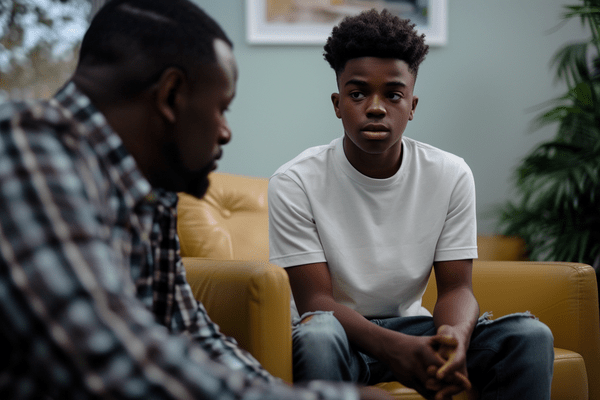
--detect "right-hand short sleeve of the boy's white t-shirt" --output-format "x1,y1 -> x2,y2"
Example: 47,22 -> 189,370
434,161 -> 477,261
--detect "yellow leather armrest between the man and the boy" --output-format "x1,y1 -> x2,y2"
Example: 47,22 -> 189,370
183,257 -> 292,382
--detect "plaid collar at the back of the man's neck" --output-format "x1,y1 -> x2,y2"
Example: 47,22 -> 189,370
54,81 -> 151,208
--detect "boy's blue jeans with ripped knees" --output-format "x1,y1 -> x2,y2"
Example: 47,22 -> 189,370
292,312 -> 554,400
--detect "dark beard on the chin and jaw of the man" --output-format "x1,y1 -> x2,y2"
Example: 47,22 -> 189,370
149,143 -> 213,199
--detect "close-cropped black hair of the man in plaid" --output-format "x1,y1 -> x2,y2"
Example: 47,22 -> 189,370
79,0 -> 232,101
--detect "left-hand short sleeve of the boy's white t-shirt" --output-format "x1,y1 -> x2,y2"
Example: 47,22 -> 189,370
268,173 -> 326,268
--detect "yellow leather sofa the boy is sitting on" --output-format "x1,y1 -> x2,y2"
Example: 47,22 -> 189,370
178,173 -> 600,400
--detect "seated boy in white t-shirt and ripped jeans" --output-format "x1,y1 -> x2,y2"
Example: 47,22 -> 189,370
269,10 -> 554,399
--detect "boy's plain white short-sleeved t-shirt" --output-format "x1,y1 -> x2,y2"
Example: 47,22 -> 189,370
268,137 -> 477,317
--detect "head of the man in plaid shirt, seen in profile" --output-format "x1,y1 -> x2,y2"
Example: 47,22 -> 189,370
73,0 -> 237,197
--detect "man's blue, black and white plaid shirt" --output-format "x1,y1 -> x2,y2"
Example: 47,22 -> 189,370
0,83 -> 357,399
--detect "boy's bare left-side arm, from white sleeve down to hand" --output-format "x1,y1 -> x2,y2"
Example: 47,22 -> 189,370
286,263 -> 445,396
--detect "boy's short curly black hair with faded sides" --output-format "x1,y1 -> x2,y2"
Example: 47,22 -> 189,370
323,9 -> 429,78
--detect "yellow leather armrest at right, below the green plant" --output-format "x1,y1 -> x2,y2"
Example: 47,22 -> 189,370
423,260 -> 600,400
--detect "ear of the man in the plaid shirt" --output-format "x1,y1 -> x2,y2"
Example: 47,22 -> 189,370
156,67 -> 186,124
